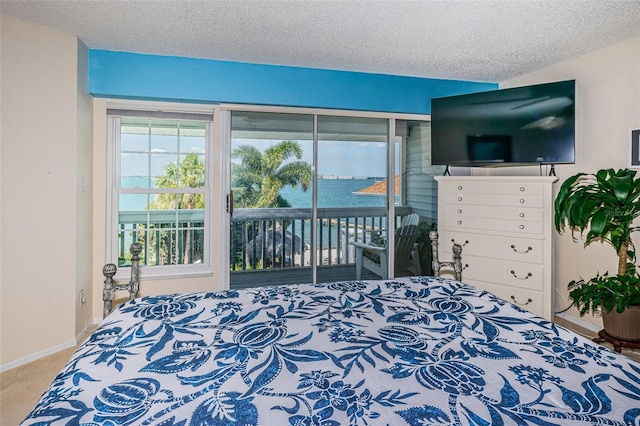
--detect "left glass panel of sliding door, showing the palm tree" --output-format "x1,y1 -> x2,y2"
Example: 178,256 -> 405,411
229,111 -> 313,288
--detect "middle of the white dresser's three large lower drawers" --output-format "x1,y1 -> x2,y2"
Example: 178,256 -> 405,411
450,255 -> 544,291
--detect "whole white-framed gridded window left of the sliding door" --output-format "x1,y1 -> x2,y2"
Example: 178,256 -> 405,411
108,110 -> 213,275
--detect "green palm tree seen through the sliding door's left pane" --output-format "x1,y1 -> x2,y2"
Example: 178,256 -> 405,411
231,141 -> 312,208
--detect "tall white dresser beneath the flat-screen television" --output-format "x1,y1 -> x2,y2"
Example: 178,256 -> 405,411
435,176 -> 557,321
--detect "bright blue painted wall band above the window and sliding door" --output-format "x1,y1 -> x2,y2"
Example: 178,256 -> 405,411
89,50 -> 498,114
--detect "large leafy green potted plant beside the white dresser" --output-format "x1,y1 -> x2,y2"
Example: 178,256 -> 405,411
554,169 -> 640,341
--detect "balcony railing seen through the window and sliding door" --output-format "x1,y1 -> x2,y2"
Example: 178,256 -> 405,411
119,206 -> 410,274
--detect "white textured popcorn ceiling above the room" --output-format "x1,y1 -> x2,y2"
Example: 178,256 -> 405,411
0,0 -> 640,82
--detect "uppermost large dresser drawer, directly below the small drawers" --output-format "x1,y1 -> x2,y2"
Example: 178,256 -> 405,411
439,230 -> 544,264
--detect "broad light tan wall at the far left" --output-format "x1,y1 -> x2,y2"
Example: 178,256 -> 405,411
0,15 -> 90,368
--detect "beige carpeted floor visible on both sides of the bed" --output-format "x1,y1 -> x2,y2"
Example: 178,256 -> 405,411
0,318 -> 640,426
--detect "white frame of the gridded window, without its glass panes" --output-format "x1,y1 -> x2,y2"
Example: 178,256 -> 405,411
106,105 -> 215,279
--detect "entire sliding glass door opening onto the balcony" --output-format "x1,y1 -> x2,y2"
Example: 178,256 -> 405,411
227,110 -> 435,288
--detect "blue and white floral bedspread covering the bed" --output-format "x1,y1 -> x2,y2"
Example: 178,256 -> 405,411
23,277 -> 640,426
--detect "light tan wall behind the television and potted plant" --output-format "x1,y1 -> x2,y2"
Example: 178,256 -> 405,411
500,38 -> 640,327
